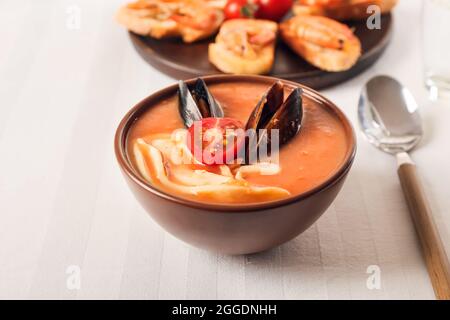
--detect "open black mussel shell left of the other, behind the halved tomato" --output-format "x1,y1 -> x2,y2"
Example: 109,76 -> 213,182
178,78 -> 224,128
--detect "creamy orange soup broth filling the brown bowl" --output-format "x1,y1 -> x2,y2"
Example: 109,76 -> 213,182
127,82 -> 349,203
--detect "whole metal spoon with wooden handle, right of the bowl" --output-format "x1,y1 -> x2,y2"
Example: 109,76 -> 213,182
358,76 -> 450,300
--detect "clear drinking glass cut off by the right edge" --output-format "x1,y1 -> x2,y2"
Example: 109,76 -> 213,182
423,0 -> 450,99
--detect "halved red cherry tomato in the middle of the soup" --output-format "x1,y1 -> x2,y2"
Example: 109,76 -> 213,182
187,118 -> 245,165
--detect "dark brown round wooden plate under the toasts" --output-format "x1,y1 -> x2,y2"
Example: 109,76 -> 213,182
129,14 -> 392,89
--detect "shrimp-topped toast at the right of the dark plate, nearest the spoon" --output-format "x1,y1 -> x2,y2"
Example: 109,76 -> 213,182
280,15 -> 361,72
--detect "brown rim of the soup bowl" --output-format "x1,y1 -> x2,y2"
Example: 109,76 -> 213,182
114,74 -> 357,212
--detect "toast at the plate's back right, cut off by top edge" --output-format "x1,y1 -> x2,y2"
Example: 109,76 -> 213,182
293,0 -> 398,20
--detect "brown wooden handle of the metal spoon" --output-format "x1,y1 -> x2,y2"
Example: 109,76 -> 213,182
397,153 -> 450,300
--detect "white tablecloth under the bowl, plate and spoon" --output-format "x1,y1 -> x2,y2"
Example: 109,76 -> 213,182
0,0 -> 450,299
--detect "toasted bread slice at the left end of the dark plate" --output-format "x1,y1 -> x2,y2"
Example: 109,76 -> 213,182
116,0 -> 224,43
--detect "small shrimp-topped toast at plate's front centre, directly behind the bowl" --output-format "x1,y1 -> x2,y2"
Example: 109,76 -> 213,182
208,19 -> 278,74
